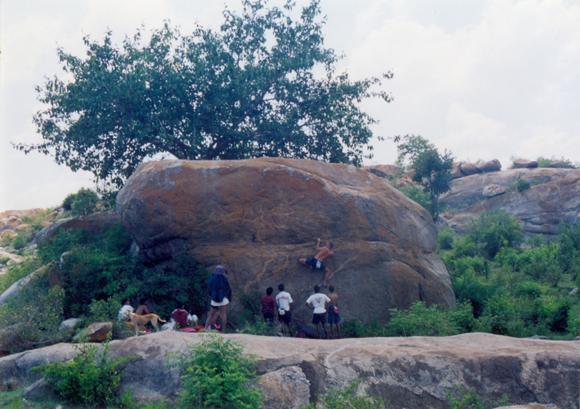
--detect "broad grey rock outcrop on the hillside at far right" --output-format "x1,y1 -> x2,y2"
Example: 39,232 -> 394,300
441,168 -> 580,234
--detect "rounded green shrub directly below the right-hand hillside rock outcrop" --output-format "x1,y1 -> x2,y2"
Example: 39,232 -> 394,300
469,211 -> 523,258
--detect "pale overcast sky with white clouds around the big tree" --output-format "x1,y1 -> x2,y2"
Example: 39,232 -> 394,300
0,0 -> 580,211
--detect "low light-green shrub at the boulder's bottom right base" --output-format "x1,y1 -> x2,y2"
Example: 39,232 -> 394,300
387,302 -> 459,336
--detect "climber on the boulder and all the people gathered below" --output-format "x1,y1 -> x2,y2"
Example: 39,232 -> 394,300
119,239 -> 340,338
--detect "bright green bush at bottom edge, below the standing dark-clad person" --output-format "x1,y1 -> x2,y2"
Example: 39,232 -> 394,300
180,335 -> 262,409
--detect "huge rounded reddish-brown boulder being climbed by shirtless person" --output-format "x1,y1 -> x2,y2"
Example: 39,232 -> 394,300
117,158 -> 454,321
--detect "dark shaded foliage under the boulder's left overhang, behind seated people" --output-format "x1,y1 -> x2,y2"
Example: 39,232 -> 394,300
39,225 -> 207,317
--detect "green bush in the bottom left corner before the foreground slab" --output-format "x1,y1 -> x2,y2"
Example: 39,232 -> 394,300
38,343 -> 134,407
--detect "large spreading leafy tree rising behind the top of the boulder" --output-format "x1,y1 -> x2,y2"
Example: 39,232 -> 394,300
16,0 -> 391,186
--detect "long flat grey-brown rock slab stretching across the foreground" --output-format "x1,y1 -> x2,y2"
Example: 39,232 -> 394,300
0,331 -> 580,409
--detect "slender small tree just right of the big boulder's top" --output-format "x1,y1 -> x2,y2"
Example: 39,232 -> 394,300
394,135 -> 453,221
